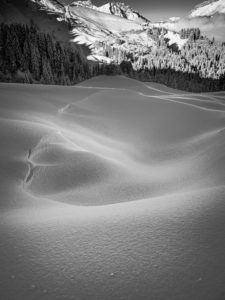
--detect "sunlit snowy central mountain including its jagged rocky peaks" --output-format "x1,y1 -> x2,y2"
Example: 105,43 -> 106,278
31,0 -> 155,63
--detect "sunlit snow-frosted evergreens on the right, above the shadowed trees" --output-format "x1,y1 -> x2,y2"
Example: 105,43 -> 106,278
102,28 -> 225,79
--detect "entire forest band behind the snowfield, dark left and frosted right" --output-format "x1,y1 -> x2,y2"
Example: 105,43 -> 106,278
0,23 -> 225,92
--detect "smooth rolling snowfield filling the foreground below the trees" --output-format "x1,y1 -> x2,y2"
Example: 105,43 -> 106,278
0,76 -> 225,300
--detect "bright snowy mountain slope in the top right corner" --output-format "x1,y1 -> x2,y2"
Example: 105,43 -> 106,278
189,0 -> 225,18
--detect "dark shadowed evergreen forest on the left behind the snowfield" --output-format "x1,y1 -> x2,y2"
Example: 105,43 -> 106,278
0,23 -> 98,85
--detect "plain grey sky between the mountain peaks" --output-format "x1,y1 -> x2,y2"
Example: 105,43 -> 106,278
62,0 -> 204,21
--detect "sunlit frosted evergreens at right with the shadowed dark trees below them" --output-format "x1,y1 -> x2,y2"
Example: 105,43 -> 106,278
98,28 -> 225,92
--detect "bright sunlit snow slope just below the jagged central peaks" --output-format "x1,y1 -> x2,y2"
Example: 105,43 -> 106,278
66,6 -> 154,62
